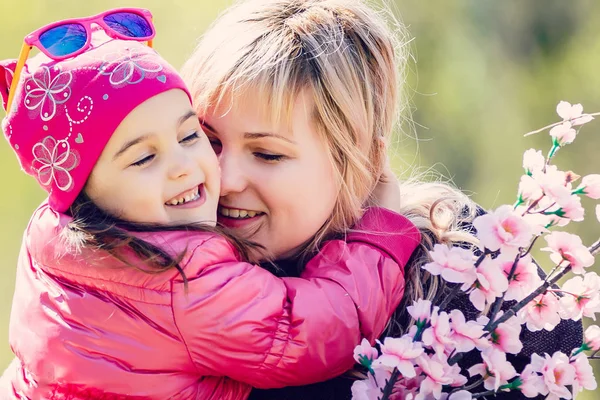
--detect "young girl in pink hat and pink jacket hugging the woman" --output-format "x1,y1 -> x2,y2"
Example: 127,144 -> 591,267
0,9 -> 420,400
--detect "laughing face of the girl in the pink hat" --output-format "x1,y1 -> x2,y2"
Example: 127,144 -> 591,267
85,89 -> 219,225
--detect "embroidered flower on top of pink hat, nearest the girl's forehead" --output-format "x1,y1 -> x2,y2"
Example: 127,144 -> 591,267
100,48 -> 163,86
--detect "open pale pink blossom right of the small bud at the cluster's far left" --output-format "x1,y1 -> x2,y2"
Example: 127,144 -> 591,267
373,336 -> 423,378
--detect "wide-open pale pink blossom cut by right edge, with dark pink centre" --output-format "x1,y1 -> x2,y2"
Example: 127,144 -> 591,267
559,272 -> 600,321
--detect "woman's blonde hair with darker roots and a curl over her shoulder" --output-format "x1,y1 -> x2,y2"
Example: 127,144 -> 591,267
182,0 -> 478,336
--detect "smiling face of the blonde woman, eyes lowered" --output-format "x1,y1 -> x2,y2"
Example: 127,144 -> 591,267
200,93 -> 339,258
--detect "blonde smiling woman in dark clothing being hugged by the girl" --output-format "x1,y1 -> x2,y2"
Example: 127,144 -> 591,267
182,0 -> 582,400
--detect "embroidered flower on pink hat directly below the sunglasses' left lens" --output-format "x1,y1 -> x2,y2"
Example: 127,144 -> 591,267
25,66 -> 73,121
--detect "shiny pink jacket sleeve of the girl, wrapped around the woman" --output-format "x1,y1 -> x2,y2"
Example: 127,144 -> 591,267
172,209 -> 420,388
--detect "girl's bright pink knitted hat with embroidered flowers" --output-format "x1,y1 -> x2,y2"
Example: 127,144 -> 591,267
0,31 -> 191,212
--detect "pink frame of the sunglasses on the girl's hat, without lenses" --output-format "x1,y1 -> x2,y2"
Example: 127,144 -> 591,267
24,8 -> 156,61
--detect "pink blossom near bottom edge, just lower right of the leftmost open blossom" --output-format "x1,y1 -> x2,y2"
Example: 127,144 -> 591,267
416,354 -> 467,400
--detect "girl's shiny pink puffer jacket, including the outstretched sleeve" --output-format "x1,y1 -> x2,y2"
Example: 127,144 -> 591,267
0,204 -> 420,400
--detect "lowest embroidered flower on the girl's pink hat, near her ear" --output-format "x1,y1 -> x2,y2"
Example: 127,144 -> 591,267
32,136 -> 79,191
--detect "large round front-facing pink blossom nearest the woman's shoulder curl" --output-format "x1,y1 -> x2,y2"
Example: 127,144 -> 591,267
473,205 -> 533,255
